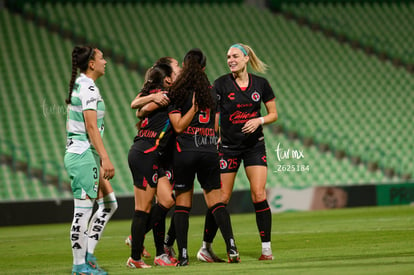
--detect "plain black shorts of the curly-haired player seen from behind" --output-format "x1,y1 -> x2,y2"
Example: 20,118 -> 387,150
174,151 -> 221,191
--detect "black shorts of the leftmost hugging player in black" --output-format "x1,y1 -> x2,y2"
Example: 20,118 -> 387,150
128,146 -> 173,188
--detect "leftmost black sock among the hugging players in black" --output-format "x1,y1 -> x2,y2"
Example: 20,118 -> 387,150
131,211 -> 149,261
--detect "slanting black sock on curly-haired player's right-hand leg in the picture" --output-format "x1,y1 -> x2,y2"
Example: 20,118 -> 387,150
210,202 -> 237,251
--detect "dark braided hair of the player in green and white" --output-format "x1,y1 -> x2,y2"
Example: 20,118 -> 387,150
65,46 -> 95,104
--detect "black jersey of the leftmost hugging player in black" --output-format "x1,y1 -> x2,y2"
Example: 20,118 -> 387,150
134,90 -> 172,153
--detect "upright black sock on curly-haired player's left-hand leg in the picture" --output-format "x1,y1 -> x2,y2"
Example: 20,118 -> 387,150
174,205 -> 191,260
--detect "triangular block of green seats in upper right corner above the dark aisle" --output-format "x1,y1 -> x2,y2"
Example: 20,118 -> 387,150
282,1 -> 414,63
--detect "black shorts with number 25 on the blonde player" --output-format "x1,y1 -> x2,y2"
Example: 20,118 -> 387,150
220,142 -> 267,173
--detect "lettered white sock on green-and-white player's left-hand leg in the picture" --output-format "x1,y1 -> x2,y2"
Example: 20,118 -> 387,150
70,199 -> 95,265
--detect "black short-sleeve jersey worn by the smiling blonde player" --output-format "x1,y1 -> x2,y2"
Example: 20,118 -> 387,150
213,74 -> 275,149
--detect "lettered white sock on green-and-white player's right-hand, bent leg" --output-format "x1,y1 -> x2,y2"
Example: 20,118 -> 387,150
88,192 -> 118,254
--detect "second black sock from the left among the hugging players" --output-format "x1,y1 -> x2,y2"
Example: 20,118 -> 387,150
151,203 -> 170,256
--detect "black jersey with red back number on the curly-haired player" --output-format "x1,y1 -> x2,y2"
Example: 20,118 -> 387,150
169,89 -> 218,152
